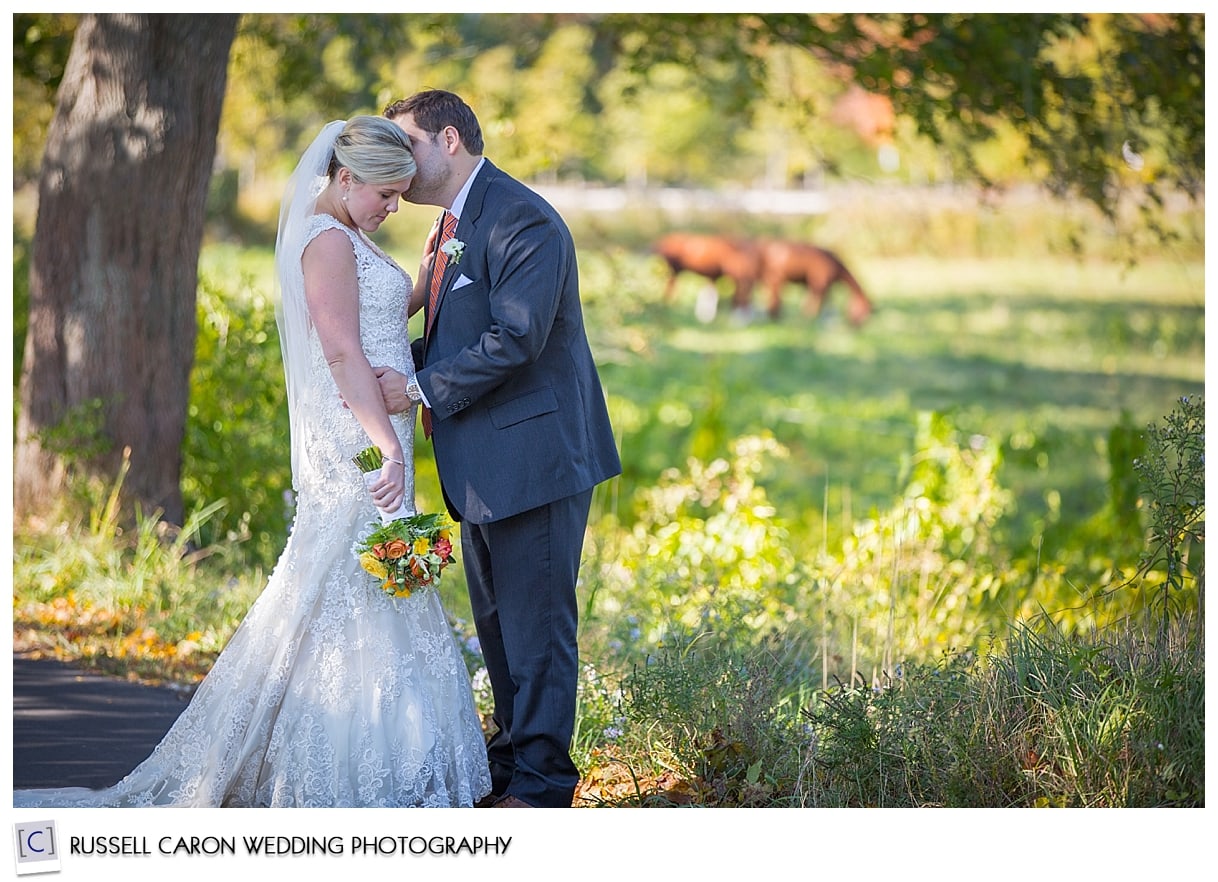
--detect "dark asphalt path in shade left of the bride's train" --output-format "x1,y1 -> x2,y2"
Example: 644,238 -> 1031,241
12,653 -> 186,789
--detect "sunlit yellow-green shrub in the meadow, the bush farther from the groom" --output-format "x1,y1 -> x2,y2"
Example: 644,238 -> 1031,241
809,413 -> 1024,682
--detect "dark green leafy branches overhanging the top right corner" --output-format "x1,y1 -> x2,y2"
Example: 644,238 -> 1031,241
817,13 -> 1205,217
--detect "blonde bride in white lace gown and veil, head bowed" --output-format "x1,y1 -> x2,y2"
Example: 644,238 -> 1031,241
15,116 -> 491,808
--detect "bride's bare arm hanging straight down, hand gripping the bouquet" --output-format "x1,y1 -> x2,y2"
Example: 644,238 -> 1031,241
301,230 -> 406,509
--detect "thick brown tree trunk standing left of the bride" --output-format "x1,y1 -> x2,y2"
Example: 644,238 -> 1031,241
13,13 -> 238,524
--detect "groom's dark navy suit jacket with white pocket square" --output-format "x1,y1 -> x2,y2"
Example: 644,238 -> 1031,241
414,161 -> 621,524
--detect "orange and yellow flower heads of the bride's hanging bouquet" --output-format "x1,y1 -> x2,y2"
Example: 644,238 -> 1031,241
354,513 -> 454,597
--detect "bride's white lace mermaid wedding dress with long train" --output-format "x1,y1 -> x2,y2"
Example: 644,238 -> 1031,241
15,214 -> 491,806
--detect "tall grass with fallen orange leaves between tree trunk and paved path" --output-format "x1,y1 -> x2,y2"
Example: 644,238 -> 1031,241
13,448 -> 263,685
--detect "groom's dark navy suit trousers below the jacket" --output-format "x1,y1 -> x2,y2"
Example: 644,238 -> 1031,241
462,490 -> 592,808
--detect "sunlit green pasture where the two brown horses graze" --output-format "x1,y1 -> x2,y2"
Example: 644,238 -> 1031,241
585,244 -> 1205,538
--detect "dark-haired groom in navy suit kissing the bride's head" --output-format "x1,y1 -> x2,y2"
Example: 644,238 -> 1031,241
378,90 -> 621,808
